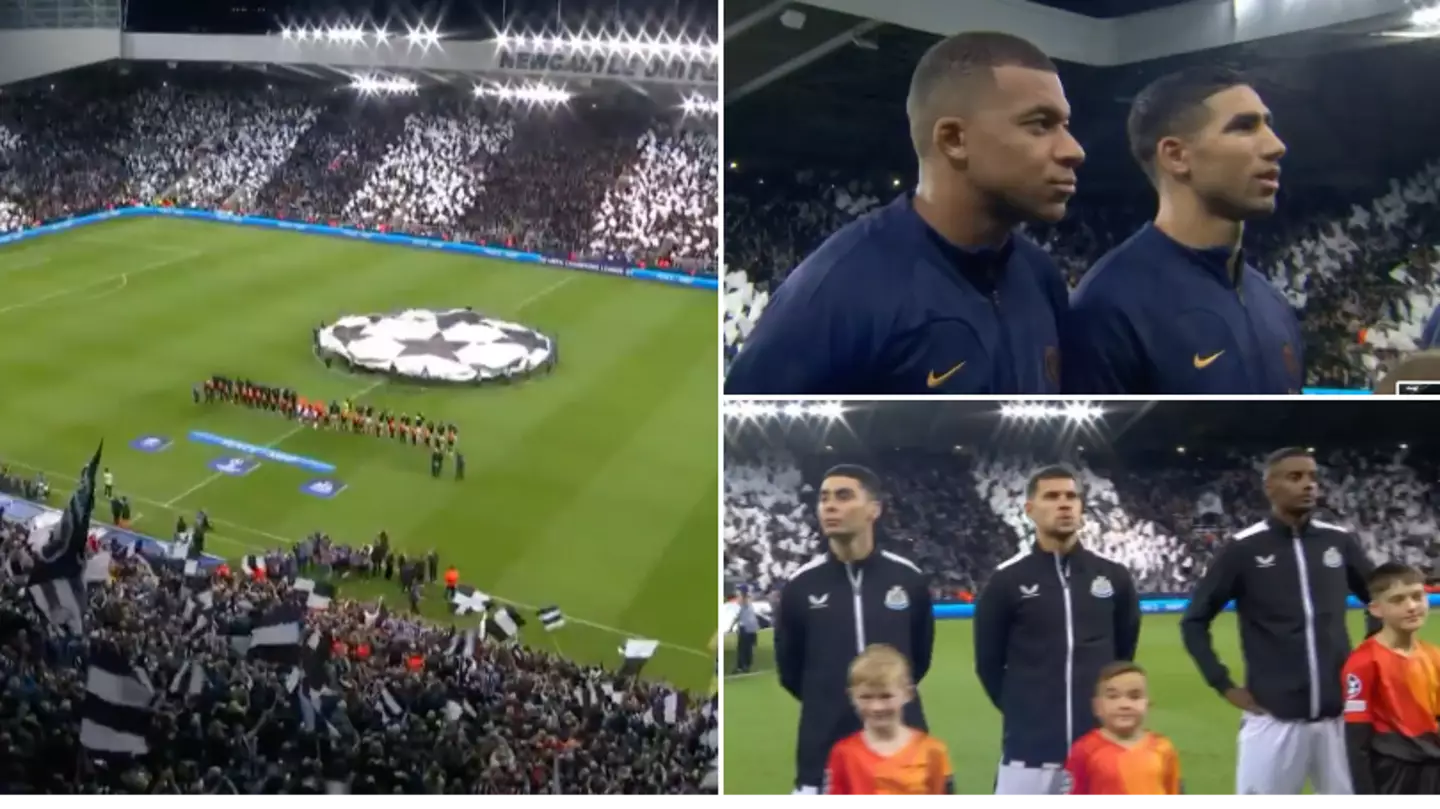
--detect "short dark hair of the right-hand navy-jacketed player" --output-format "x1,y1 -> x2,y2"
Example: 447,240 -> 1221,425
1125,66 -> 1250,183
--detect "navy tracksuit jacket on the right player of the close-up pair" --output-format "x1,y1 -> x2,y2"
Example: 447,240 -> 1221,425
1061,225 -> 1305,394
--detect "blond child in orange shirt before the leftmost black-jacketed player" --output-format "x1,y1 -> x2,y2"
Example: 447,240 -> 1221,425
821,643 -> 955,799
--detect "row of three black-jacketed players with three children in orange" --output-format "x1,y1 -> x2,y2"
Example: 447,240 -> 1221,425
775,448 -> 1440,799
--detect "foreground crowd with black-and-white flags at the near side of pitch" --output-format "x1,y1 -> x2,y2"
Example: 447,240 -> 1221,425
0,506 -> 717,800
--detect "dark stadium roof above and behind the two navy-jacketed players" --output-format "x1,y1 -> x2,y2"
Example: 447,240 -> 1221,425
723,0 -> 1440,193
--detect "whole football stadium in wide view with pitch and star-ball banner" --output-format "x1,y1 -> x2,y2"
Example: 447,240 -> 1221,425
0,0 -> 719,800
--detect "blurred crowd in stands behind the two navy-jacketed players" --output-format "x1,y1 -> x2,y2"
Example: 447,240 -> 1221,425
723,161 -> 1440,389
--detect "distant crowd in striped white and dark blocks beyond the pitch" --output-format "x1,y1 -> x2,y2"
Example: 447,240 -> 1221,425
0,71 -> 719,272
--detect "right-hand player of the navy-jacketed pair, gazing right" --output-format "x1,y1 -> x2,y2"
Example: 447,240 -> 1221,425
1061,66 -> 1305,394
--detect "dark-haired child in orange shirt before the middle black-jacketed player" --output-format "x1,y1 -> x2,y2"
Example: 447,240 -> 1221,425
1064,661 -> 1184,797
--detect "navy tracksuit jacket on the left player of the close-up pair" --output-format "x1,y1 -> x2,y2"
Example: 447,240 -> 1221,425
724,196 -> 1067,396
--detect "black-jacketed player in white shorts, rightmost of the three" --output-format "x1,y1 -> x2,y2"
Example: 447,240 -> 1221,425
1181,446 -> 1374,800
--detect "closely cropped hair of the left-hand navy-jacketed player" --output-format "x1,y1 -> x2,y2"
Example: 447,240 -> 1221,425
904,30 -> 1058,155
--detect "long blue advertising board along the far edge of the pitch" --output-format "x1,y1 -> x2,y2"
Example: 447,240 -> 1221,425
0,206 -> 720,292
